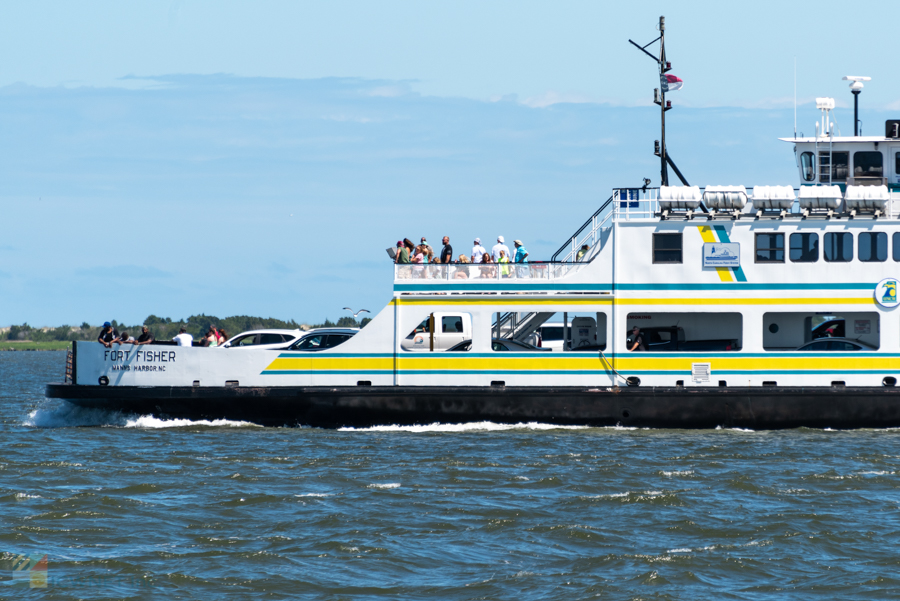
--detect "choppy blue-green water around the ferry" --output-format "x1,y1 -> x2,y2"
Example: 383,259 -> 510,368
0,352 -> 900,600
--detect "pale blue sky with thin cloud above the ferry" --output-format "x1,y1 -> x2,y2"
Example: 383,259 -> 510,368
0,1 -> 900,325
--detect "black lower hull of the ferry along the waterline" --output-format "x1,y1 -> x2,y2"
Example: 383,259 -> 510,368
47,384 -> 900,430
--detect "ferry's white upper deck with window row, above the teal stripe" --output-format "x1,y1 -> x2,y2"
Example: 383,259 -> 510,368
394,186 -> 900,296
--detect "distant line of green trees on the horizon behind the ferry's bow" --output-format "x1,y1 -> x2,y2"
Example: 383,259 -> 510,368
0,313 -> 372,342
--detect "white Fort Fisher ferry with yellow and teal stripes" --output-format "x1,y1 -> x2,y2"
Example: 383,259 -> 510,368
47,22 -> 900,429
